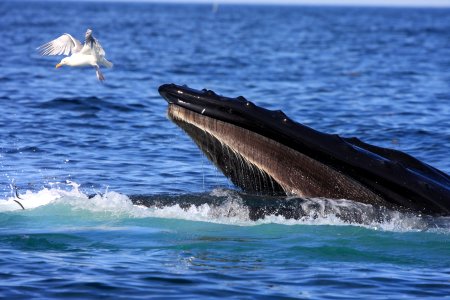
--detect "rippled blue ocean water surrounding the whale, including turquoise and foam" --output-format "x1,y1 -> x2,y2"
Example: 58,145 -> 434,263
0,1 -> 450,299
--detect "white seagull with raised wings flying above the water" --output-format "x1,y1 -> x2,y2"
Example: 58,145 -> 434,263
37,29 -> 113,81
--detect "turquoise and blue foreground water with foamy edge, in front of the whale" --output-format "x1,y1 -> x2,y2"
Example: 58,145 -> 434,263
0,191 -> 450,298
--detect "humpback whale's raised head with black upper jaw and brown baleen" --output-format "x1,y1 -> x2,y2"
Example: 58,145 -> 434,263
159,84 -> 450,216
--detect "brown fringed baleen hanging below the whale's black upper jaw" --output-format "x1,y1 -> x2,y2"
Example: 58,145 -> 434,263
168,104 -> 392,207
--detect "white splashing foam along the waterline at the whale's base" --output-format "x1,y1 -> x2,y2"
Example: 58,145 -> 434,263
0,182 -> 442,231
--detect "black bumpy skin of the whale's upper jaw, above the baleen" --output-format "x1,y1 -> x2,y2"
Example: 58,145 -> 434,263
159,84 -> 450,216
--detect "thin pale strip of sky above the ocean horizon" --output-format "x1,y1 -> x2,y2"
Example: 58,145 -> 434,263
114,0 -> 450,7
